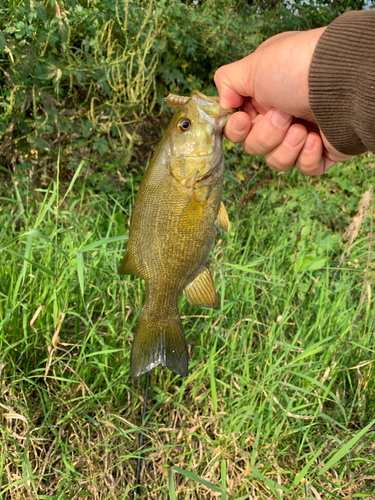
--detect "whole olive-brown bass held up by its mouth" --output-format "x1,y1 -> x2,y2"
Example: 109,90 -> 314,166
120,90 -> 235,378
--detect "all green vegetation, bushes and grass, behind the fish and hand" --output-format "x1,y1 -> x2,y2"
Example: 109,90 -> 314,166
0,0 -> 375,500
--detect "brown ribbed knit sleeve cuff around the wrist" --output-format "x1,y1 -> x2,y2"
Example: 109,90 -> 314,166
309,9 -> 375,155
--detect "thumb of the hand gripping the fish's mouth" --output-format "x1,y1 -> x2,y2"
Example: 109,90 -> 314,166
214,54 -> 254,109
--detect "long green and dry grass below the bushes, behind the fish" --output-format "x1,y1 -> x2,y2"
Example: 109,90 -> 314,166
0,149 -> 375,500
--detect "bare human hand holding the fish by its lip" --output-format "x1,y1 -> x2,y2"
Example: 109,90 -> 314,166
215,28 -> 350,175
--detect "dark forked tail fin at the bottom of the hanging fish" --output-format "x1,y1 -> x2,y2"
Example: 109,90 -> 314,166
130,309 -> 188,378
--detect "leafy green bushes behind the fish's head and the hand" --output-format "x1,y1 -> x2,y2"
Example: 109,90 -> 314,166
0,0 -> 372,180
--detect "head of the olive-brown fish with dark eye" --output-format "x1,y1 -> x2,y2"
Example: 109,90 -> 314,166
166,90 -> 235,185
